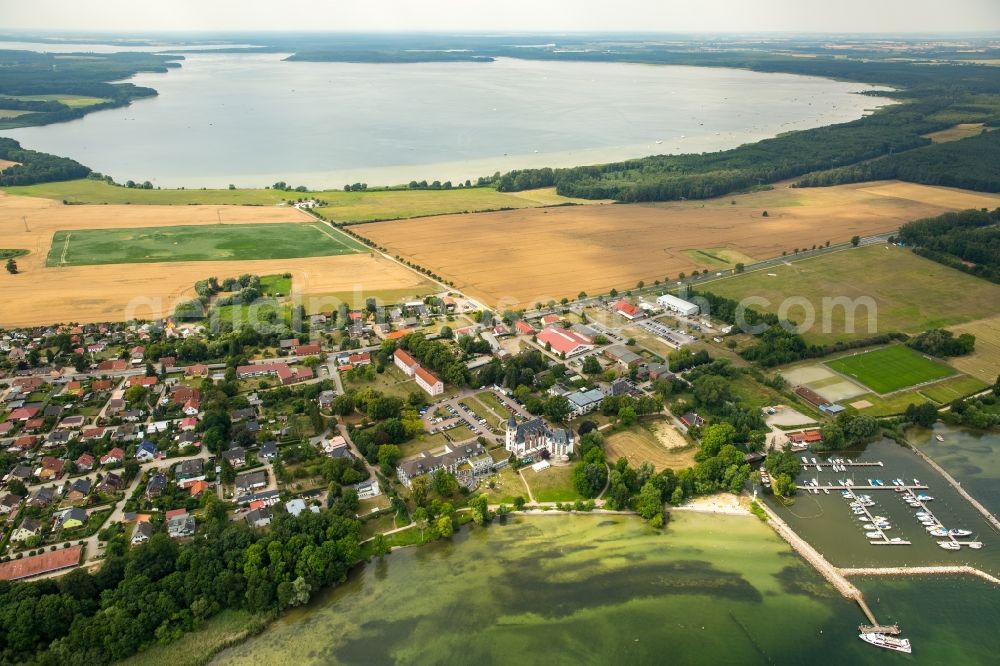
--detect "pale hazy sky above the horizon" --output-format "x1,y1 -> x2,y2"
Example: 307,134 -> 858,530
0,0 -> 1000,33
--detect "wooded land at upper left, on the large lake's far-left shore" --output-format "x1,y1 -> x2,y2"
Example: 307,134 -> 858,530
0,50 -> 181,129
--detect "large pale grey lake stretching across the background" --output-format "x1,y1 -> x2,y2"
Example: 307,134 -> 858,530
0,54 -> 889,187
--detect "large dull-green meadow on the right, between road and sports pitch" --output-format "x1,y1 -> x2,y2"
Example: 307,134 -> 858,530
702,245 -> 1000,344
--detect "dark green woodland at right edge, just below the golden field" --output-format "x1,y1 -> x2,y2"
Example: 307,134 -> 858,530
899,208 -> 1000,283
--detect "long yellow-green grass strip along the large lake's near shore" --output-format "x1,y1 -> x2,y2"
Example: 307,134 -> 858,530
4,179 -> 594,222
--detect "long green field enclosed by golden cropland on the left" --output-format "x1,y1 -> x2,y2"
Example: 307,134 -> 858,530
46,223 -> 367,266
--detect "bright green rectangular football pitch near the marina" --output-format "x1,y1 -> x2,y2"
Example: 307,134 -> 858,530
826,345 -> 955,394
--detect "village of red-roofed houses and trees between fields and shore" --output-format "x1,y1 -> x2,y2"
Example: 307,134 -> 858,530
0,282 -> 820,579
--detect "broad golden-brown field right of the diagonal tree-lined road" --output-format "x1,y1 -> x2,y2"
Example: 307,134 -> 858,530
355,181 -> 1000,309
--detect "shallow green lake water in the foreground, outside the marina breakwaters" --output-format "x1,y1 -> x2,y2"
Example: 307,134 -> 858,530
215,512 -> 1000,666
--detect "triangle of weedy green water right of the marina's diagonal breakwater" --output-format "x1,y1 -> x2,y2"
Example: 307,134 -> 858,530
906,423 -> 1000,515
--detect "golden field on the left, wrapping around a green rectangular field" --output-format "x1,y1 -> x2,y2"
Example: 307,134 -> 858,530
0,194 -> 434,326
